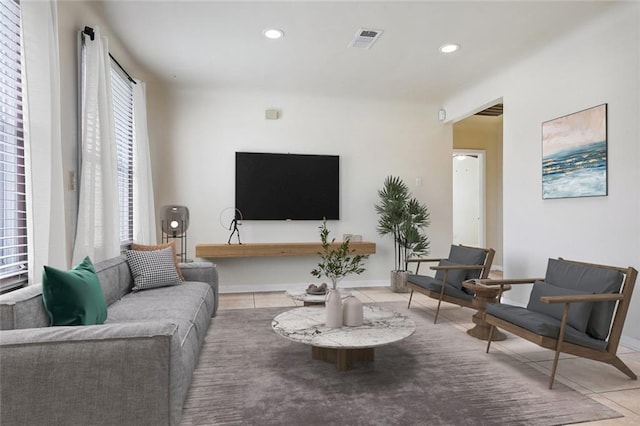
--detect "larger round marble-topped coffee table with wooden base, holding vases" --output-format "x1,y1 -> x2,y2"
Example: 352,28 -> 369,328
271,305 -> 416,371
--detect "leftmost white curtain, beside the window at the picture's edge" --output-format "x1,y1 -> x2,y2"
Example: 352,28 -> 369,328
21,1 -> 68,283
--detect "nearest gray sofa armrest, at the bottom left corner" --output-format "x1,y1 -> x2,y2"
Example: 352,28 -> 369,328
0,322 -> 184,425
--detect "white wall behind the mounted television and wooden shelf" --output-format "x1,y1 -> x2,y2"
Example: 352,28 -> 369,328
154,88 -> 451,291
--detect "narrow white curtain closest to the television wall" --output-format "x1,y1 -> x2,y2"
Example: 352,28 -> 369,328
133,80 -> 157,244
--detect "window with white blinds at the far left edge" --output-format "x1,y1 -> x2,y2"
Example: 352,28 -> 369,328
0,0 -> 27,292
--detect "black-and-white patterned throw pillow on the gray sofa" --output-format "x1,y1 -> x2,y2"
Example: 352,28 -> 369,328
127,247 -> 181,291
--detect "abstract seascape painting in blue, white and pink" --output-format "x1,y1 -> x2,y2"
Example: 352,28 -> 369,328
542,104 -> 607,199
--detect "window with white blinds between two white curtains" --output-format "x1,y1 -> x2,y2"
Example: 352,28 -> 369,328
111,60 -> 133,246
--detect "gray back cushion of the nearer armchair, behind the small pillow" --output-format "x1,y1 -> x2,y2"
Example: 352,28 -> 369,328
545,259 -> 623,340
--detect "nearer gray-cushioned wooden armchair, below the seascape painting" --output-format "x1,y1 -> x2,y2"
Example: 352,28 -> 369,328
481,258 -> 638,389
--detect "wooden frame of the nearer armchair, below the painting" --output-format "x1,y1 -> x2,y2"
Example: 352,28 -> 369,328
481,258 -> 638,389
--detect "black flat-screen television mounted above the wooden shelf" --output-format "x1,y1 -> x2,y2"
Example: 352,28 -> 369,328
236,152 -> 340,220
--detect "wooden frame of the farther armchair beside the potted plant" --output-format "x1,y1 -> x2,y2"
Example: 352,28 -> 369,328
407,244 -> 503,324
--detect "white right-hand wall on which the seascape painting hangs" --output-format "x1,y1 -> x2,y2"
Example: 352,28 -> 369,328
445,3 -> 640,339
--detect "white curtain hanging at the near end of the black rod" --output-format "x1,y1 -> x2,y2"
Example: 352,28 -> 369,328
73,27 -> 120,264
